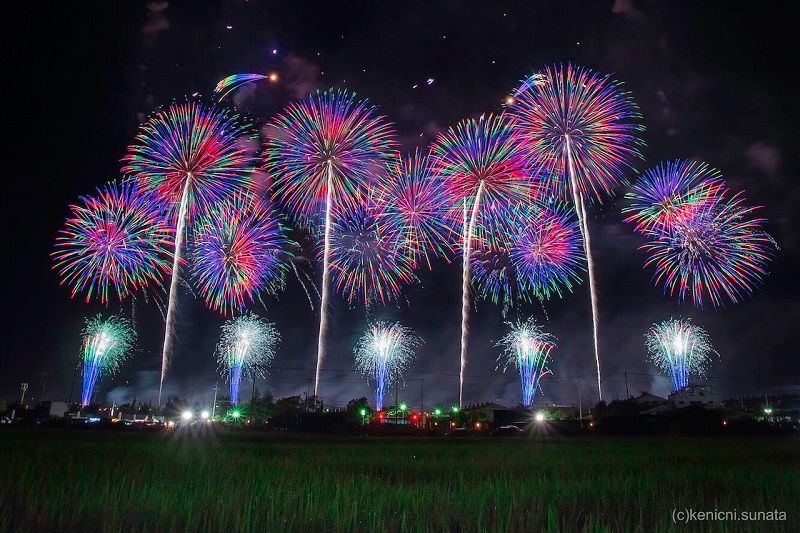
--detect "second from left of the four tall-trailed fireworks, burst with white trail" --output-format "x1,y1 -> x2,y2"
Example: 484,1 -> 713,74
265,89 -> 395,395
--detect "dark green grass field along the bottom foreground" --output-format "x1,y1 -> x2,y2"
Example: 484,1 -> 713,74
0,430 -> 800,532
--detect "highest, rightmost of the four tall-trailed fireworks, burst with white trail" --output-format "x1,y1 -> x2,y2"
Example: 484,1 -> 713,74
509,65 -> 644,399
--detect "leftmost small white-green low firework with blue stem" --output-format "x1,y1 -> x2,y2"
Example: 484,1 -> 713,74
81,315 -> 134,407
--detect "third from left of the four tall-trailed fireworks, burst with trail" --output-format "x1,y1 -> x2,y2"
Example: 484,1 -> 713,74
432,111 -> 534,404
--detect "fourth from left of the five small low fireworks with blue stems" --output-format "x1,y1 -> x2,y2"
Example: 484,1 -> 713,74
496,317 -> 556,407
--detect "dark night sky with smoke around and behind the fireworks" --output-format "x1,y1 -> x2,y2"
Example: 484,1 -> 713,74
0,0 -> 800,407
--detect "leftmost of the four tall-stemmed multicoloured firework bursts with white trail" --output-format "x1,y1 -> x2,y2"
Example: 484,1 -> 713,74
122,102 -> 256,405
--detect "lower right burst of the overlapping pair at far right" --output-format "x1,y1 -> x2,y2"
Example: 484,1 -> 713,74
642,191 -> 776,307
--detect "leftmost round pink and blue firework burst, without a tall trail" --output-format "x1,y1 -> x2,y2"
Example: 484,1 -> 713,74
52,182 -> 172,304
